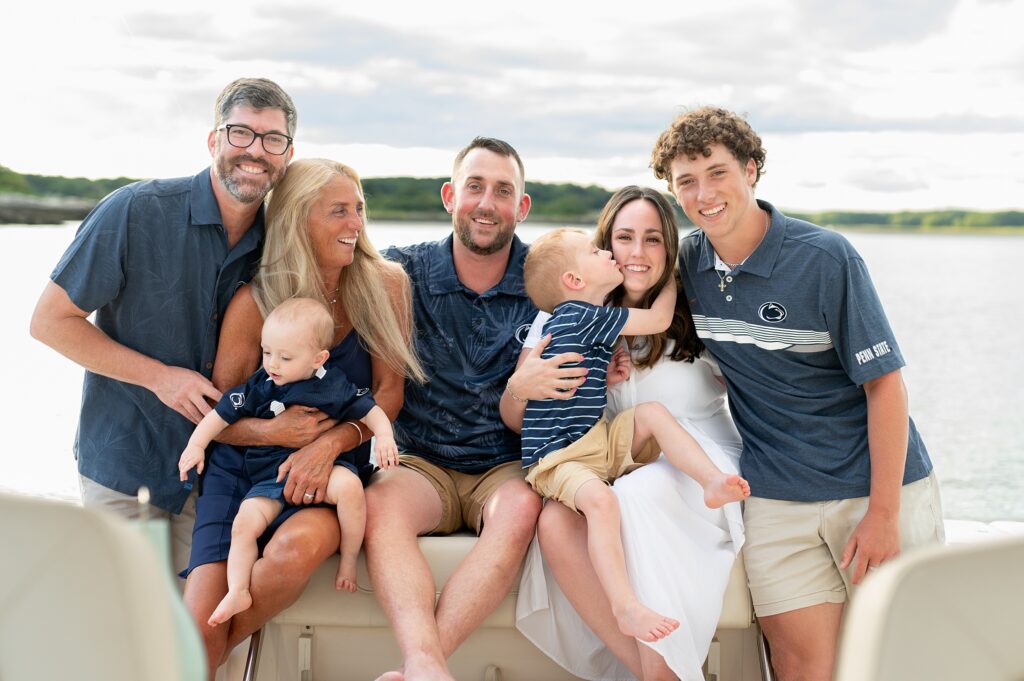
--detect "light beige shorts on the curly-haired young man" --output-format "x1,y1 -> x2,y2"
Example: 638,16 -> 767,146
743,472 -> 945,618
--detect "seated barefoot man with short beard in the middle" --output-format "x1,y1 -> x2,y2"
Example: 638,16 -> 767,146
365,137 -> 541,679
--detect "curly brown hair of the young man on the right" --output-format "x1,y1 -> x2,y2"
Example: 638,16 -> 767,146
650,107 -> 765,189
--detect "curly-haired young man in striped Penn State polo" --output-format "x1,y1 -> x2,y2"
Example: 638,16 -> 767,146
651,107 -> 944,681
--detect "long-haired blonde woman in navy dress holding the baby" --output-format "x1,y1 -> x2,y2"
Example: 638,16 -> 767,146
185,159 -> 423,678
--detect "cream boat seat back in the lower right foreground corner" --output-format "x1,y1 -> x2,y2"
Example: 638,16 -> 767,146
836,536 -> 1024,681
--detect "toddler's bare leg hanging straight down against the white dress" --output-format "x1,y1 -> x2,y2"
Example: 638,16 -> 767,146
574,478 -> 679,641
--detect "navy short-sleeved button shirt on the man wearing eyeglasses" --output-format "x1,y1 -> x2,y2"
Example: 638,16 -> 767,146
50,169 -> 263,513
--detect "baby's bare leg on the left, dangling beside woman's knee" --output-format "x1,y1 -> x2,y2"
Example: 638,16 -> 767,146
207,497 -> 284,627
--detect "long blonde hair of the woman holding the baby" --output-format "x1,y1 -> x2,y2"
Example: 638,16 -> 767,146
252,159 -> 426,382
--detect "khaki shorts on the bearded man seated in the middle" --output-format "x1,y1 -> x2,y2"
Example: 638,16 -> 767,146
398,454 -> 523,535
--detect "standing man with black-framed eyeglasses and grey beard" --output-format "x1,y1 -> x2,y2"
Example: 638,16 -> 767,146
31,78 -> 296,572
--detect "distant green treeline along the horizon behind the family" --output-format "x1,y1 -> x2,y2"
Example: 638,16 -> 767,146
0,166 -> 1024,230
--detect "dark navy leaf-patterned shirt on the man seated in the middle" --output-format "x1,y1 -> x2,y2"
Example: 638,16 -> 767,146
384,236 -> 537,473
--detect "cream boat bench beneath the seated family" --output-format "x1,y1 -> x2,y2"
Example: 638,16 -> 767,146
235,536 -> 753,681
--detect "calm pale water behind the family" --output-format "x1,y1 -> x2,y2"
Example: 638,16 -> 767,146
0,222 -> 1024,520
